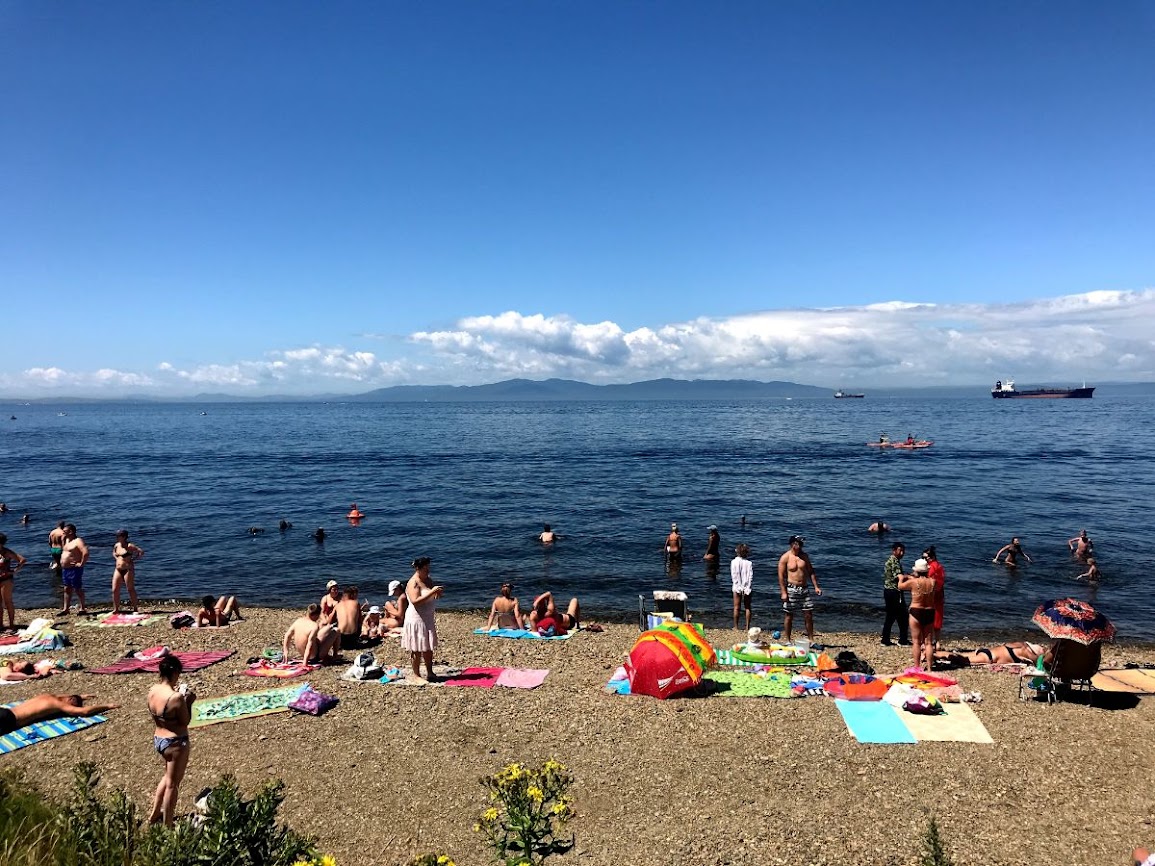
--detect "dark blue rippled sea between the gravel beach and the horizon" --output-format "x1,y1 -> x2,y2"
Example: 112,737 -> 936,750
0,391 -> 1155,640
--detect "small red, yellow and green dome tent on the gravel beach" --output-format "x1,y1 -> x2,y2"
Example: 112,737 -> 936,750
626,622 -> 717,700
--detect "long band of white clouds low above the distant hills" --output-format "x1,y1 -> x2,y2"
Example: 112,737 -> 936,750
0,289 -> 1155,397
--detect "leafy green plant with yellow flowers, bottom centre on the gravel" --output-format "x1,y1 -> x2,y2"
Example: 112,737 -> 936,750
474,759 -> 574,866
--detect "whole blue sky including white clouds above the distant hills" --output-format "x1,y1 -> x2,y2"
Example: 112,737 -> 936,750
0,0 -> 1155,396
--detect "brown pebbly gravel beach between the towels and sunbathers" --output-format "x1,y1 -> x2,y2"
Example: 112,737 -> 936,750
0,607 -> 1155,866
